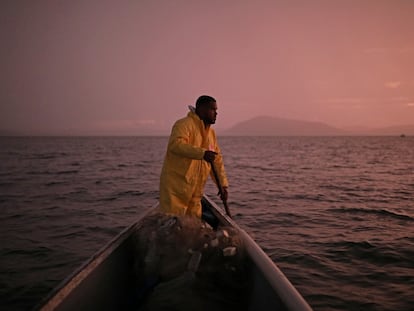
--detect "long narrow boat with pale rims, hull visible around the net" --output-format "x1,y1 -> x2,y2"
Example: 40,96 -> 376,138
35,196 -> 312,311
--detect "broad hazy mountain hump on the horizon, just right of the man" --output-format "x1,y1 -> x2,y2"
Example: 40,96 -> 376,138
222,116 -> 349,136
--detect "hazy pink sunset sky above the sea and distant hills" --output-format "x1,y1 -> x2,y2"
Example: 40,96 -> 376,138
0,0 -> 414,134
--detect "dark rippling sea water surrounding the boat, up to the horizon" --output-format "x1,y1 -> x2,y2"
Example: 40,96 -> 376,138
0,137 -> 414,310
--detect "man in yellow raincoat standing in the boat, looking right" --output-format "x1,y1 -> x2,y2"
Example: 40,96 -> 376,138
160,95 -> 228,217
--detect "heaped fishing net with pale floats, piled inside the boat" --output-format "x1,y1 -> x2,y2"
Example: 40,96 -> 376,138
134,212 -> 248,310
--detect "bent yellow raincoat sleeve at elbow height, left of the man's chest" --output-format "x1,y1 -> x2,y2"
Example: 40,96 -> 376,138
169,121 -> 206,160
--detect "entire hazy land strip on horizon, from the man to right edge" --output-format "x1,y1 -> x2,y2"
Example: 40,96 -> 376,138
220,116 -> 414,136
